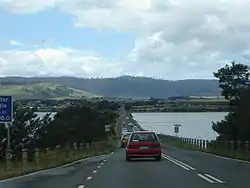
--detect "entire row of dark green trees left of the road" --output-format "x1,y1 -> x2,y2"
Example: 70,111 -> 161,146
0,101 -> 118,159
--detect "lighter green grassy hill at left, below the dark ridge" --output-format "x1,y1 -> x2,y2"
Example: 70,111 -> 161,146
0,83 -> 97,100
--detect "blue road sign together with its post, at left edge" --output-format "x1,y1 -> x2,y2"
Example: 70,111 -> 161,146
0,96 -> 13,167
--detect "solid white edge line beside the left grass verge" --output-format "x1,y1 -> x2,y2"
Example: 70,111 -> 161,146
0,154 -> 110,183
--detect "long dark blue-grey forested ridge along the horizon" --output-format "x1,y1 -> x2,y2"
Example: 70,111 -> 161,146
0,76 -> 220,98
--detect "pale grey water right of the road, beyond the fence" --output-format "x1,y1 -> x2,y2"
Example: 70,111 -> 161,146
133,112 -> 227,140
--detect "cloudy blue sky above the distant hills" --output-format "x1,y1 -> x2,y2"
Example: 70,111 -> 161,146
0,0 -> 250,80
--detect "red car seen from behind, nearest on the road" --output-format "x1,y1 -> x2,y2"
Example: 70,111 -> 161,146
126,131 -> 161,161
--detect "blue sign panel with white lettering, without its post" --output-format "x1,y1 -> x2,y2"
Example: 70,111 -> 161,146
0,96 -> 13,123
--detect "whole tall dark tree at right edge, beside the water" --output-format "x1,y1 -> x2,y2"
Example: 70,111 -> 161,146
212,62 -> 250,141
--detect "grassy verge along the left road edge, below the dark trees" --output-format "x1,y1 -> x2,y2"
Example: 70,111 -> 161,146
0,138 -> 117,180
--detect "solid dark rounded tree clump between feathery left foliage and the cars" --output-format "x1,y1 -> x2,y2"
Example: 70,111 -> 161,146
44,105 -> 117,146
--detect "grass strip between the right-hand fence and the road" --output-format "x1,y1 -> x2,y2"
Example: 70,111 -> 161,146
159,134 -> 250,161
